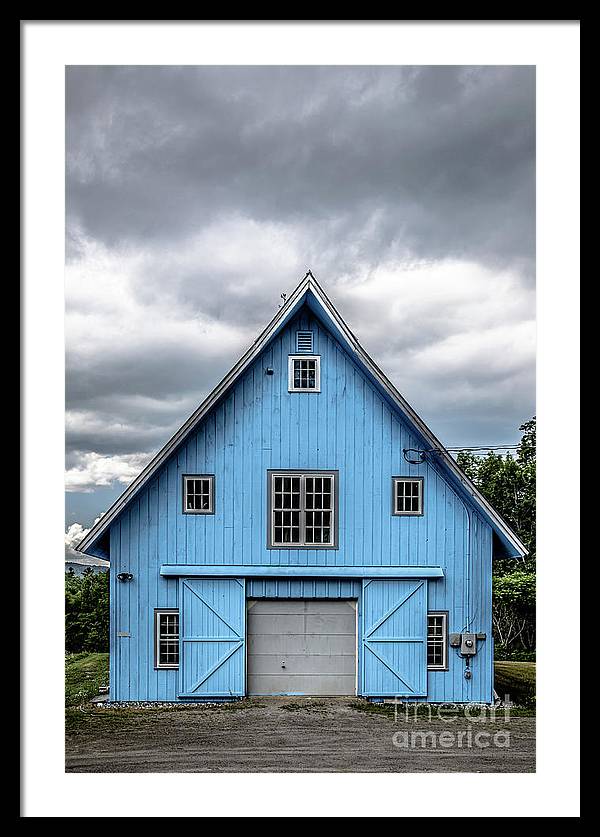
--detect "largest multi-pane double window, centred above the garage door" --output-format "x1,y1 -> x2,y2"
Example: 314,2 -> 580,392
269,471 -> 336,548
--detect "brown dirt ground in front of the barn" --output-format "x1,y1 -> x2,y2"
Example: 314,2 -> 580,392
66,698 -> 535,773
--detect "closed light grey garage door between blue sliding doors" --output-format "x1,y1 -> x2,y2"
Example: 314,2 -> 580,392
247,599 -> 356,695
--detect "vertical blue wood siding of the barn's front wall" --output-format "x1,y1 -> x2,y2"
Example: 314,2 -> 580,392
110,308 -> 492,702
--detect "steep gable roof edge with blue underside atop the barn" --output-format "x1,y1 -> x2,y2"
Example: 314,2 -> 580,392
77,271 -> 527,557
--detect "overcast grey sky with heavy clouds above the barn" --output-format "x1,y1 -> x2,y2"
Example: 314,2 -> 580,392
66,67 -> 535,537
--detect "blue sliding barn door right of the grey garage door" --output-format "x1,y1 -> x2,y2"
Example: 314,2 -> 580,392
362,579 -> 427,697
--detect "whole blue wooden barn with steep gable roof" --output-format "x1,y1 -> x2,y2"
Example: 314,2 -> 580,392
79,273 -> 525,703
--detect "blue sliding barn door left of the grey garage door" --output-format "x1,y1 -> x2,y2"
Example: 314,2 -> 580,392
179,578 -> 246,698
